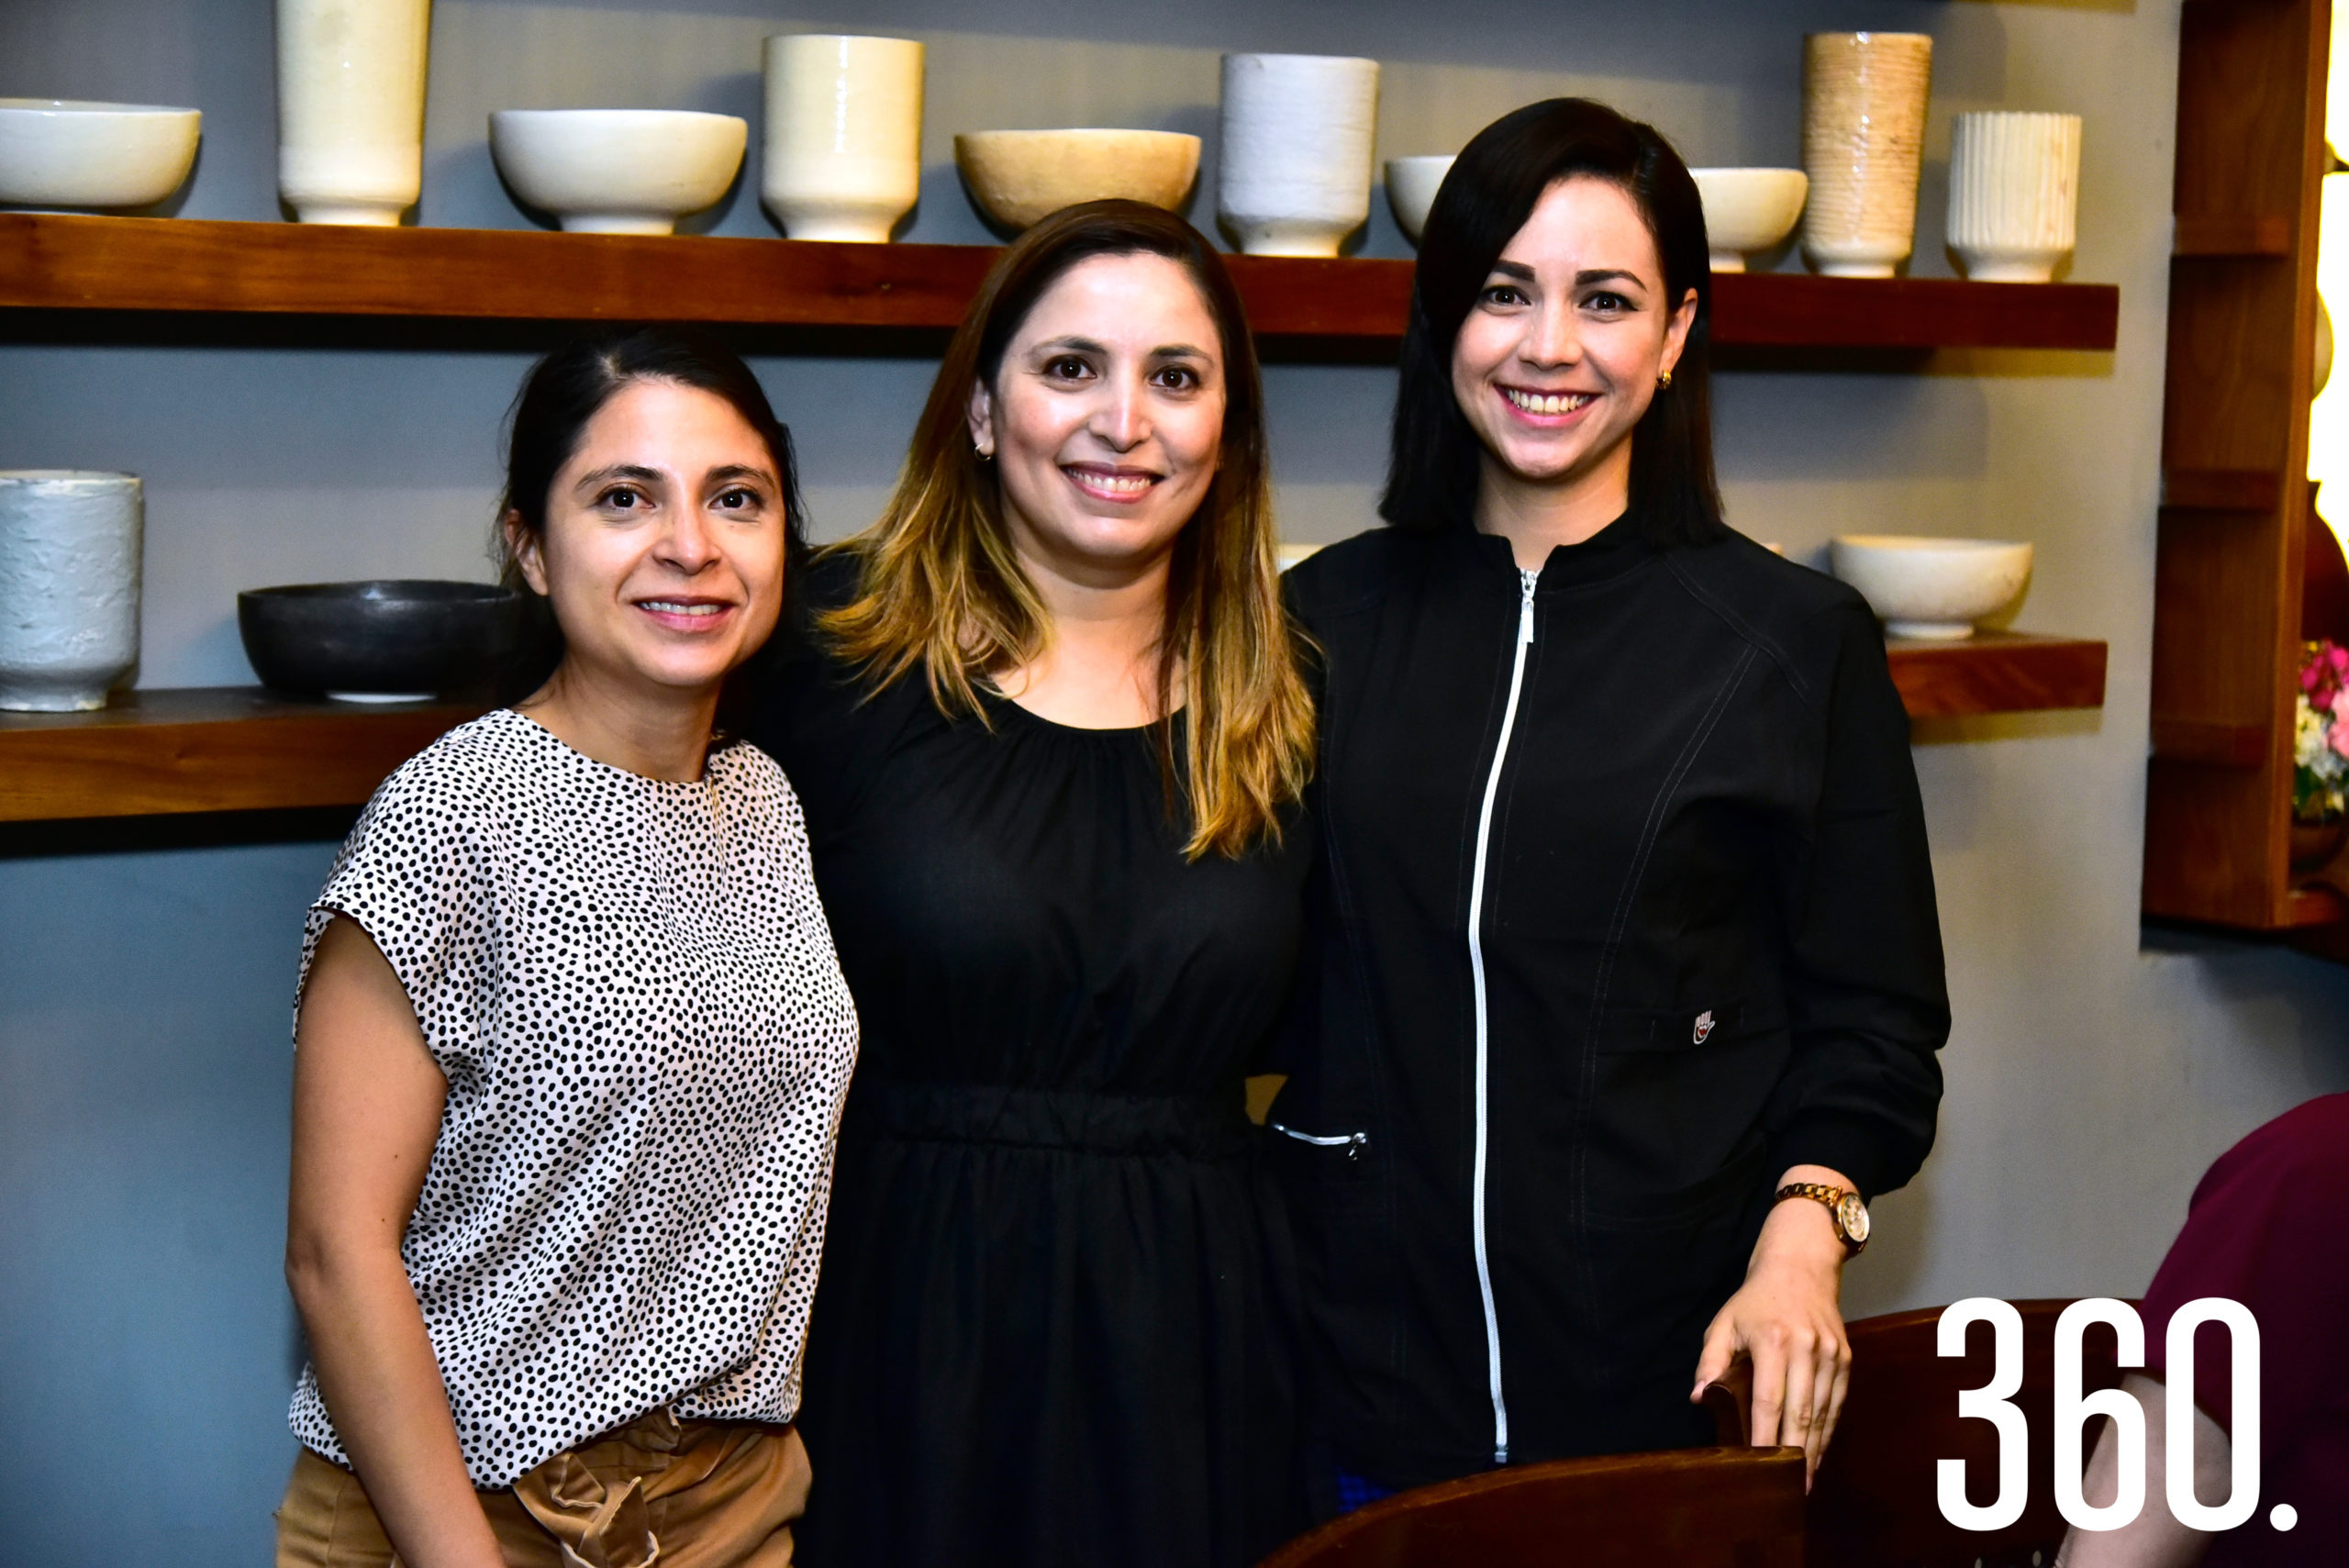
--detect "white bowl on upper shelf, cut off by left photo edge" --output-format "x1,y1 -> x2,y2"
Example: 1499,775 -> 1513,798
0,98 -> 205,206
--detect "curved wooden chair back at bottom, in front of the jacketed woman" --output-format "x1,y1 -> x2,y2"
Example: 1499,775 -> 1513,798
1262,1449 -> 1802,1568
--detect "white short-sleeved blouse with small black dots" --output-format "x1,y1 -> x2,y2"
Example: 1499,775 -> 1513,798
294,709 -> 857,1488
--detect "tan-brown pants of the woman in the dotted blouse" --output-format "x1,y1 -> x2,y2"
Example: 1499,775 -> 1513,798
277,1411 -> 808,1568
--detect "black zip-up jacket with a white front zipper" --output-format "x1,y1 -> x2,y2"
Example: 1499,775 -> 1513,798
1271,518 -> 1950,1485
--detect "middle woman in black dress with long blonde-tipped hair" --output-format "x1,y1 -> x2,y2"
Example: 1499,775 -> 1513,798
751,202 -> 1310,1568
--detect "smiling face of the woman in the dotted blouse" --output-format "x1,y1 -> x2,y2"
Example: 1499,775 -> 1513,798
507,380 -> 787,693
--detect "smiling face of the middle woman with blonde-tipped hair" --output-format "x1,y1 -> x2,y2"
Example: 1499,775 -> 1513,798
970,253 -> 1224,582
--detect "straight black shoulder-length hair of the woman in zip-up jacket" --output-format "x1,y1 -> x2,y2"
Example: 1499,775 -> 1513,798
1379,98 -> 1724,545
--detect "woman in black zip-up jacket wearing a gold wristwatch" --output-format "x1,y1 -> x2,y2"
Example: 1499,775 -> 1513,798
1274,98 -> 1950,1505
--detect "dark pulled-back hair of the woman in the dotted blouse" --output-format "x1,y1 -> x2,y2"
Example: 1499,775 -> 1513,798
491,327 -> 808,695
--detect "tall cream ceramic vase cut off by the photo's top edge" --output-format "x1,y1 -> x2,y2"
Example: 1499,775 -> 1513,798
277,0 -> 432,228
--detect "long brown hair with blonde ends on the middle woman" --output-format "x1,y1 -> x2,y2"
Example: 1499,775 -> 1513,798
818,202 -> 1313,859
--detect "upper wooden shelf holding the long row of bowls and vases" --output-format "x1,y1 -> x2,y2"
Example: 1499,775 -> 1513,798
0,214 -> 2121,350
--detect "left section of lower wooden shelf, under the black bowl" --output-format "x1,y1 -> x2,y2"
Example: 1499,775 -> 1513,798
0,685 -> 482,821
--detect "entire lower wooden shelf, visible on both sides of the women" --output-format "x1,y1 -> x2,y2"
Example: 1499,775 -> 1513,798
0,631 -> 2105,821
